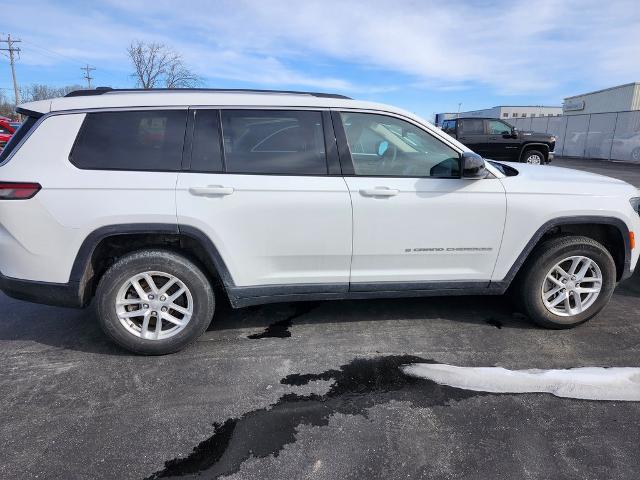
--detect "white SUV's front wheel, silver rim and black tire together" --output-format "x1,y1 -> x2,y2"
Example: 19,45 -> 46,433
518,236 -> 616,329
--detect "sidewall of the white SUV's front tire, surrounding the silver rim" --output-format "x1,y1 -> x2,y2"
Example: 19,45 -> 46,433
523,243 -> 616,328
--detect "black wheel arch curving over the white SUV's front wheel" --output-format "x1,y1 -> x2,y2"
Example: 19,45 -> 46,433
490,216 -> 631,290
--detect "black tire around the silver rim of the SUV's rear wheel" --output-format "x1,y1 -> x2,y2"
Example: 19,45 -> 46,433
96,250 -> 215,355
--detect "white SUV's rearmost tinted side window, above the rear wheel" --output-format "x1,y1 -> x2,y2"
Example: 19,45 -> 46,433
71,110 -> 187,171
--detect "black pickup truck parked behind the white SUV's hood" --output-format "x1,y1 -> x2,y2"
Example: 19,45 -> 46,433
442,117 -> 556,165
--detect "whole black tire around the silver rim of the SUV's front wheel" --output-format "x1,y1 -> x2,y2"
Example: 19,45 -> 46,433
516,236 -> 616,329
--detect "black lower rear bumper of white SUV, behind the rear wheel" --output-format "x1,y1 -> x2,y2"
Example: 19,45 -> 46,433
0,273 -> 84,308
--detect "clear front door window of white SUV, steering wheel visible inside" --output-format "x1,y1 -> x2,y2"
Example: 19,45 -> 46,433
340,112 -> 460,178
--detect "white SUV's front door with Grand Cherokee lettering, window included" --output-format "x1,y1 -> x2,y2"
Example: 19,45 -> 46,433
334,112 -> 506,290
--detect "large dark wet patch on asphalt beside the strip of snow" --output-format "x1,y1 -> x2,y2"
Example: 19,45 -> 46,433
148,355 -> 487,479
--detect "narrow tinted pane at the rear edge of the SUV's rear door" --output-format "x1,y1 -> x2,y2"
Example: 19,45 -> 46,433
191,110 -> 223,172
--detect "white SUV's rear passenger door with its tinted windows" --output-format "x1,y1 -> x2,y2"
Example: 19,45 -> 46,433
177,109 -> 351,288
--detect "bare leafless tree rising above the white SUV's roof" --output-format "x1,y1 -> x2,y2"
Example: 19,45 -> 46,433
127,40 -> 201,89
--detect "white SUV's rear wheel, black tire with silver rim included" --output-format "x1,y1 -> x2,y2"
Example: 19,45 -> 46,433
96,250 -> 215,355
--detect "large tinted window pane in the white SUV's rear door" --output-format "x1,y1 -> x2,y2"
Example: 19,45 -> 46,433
222,110 -> 327,175
